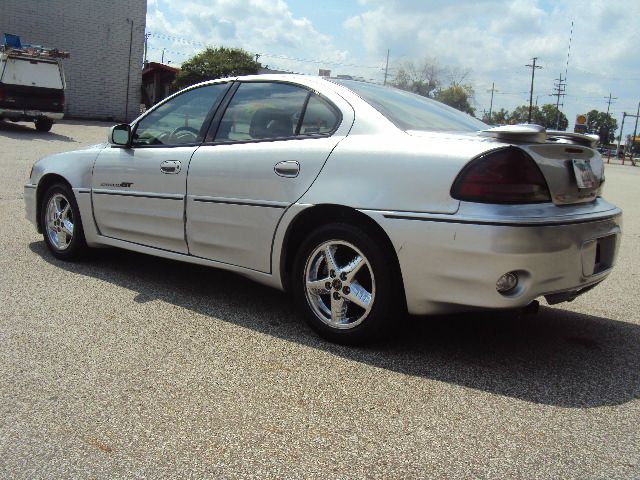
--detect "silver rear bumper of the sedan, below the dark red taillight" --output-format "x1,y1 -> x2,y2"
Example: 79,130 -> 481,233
365,202 -> 622,315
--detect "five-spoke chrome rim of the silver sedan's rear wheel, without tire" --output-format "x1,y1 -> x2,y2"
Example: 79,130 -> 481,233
304,240 -> 376,329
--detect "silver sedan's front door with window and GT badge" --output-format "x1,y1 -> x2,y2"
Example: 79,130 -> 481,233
92,83 -> 230,253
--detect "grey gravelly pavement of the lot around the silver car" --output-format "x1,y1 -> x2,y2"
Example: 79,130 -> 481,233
0,121 -> 640,479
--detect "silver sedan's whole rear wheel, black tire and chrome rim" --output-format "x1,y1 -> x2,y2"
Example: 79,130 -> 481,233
291,223 -> 400,345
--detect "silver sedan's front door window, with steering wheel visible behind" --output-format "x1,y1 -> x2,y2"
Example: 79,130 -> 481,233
133,83 -> 228,146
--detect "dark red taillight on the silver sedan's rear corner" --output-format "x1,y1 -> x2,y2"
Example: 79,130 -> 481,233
451,147 -> 551,203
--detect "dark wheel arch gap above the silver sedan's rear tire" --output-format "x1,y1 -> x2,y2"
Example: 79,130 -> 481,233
280,204 -> 405,302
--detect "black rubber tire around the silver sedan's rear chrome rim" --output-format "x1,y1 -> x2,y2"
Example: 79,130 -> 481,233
292,223 -> 394,344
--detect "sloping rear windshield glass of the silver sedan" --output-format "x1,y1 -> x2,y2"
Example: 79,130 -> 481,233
331,78 -> 489,132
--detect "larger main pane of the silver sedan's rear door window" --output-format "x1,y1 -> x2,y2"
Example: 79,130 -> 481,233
215,82 -> 309,142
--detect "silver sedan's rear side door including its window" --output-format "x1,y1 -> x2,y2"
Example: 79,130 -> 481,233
186,81 -> 353,273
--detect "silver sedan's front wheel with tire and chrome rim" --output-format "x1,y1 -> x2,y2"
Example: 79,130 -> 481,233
40,184 -> 88,261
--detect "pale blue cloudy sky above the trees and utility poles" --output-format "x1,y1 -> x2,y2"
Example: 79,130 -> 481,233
147,0 -> 640,140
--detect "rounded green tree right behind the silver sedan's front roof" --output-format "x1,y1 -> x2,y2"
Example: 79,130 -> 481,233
175,47 -> 261,88
